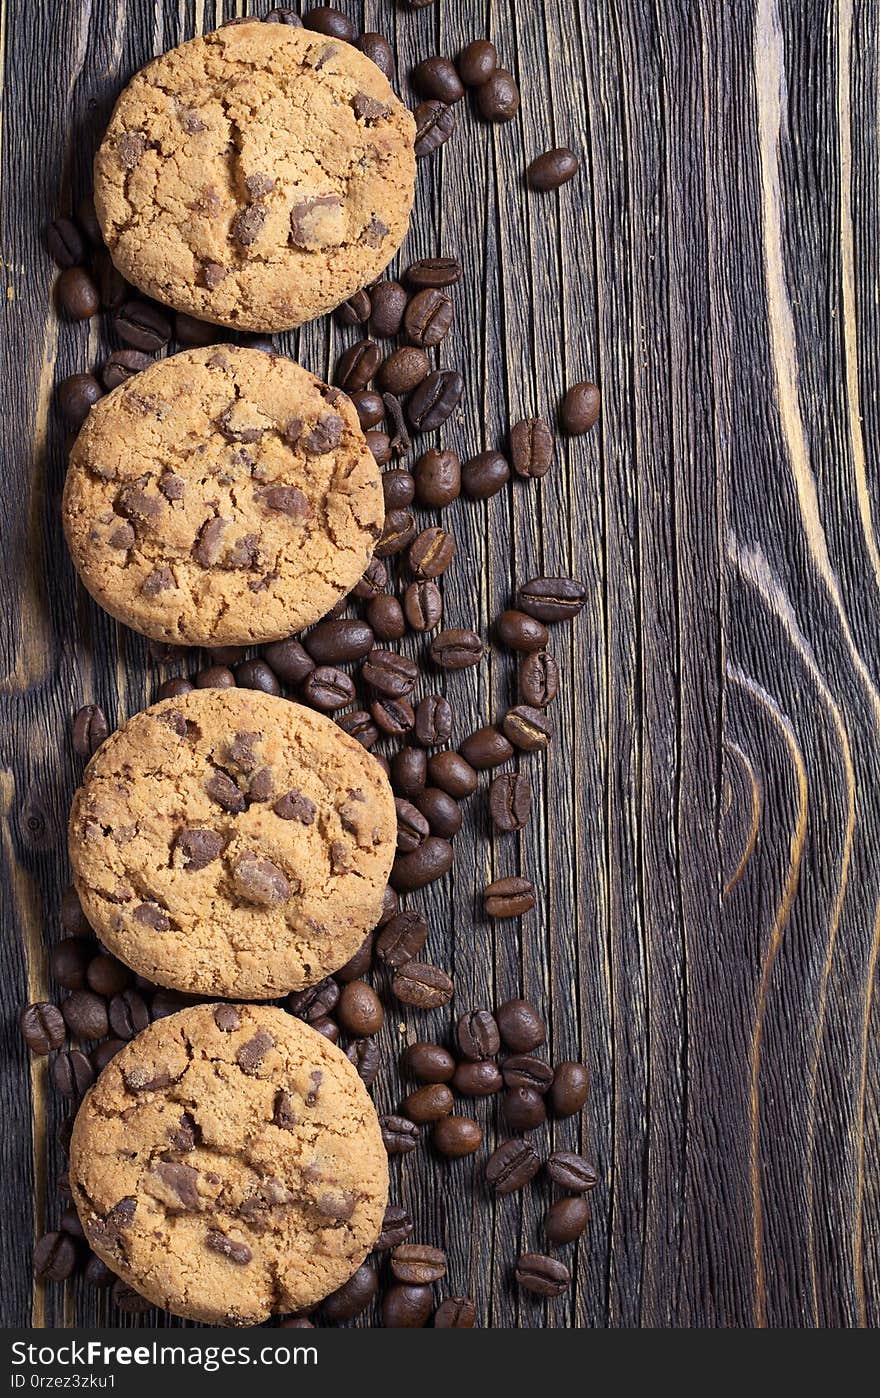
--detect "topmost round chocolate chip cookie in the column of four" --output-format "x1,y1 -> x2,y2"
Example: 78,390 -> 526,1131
95,21 -> 416,330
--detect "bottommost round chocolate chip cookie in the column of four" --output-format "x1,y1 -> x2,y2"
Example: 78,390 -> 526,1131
70,1004 -> 388,1325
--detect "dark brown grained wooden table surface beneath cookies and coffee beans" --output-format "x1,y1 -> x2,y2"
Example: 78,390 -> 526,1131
0,0 -> 880,1327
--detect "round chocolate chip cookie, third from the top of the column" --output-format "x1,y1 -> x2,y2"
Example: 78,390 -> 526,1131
70,689 -> 396,1000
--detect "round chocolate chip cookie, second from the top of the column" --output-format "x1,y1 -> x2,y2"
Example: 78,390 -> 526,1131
63,346 -> 385,646
